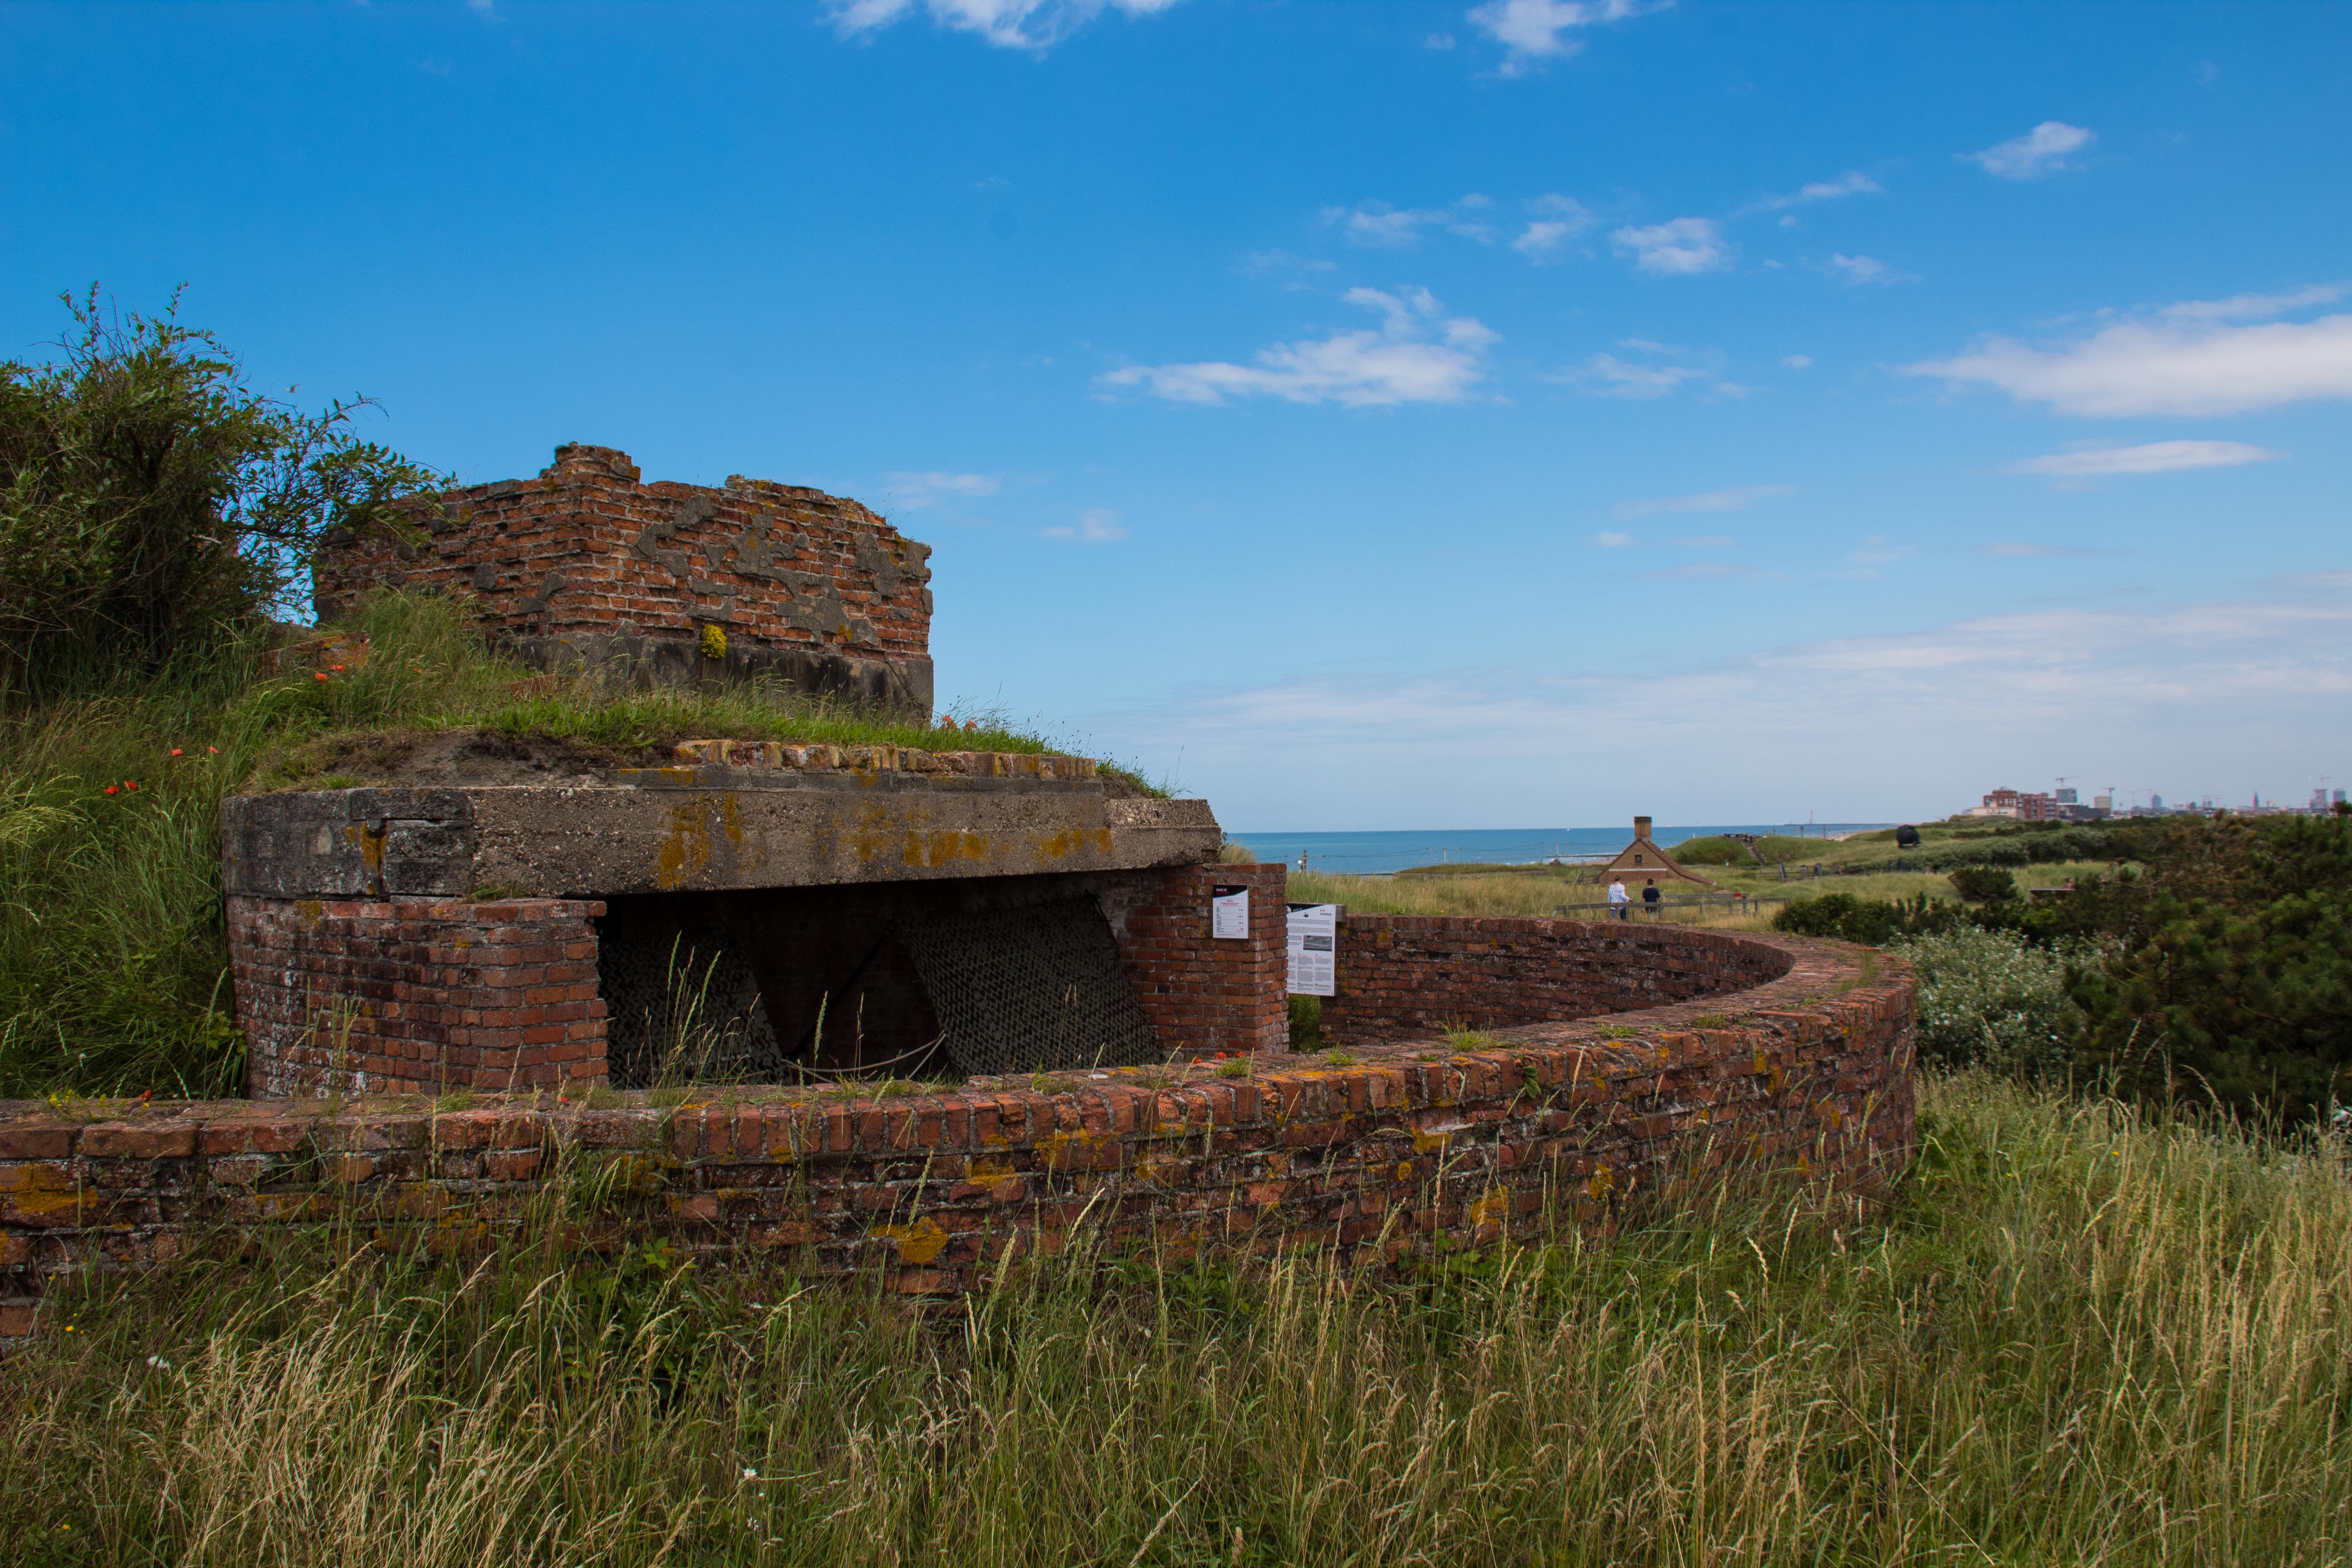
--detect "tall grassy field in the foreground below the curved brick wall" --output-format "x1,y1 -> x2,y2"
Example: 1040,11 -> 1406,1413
0,1077 -> 2352,1568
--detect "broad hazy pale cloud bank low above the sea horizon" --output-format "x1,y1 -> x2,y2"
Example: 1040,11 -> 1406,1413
1084,573 -> 2352,834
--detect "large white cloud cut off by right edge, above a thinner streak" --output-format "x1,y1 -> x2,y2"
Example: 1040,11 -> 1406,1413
1903,289 -> 2352,418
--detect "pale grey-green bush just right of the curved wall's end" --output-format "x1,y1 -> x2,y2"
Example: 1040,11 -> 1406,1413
1891,926 -> 2082,1077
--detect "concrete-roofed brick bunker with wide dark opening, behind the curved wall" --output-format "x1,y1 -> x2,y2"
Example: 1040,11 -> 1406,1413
223,740 -> 1287,1096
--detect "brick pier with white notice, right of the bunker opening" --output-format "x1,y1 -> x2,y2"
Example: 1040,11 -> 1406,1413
1103,865 -> 1291,1055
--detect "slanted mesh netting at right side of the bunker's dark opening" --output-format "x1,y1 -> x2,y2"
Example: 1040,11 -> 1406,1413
898,898 -> 1162,1074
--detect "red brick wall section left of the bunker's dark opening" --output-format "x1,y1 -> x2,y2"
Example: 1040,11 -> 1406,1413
228,898 -> 604,1098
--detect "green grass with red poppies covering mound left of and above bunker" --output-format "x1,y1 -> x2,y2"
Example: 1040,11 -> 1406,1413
0,595 -> 1082,1098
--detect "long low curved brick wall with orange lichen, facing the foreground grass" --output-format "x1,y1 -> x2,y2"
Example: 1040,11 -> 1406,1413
0,921 -> 1915,1335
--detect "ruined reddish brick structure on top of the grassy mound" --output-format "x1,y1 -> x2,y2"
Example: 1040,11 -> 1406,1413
315,444 -> 931,710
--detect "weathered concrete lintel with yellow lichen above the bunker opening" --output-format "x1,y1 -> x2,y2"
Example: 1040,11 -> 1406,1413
221,769 -> 1220,898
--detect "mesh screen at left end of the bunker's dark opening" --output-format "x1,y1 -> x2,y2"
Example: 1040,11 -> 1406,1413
598,933 -> 783,1088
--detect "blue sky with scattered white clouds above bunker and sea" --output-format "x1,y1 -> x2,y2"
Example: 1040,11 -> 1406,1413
0,0 -> 2352,830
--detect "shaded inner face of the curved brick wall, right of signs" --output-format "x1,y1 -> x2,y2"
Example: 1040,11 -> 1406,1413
1322,915 -> 1788,1041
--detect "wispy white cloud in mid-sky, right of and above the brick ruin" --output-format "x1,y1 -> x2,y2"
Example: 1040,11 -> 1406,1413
1103,289 -> 1496,407
